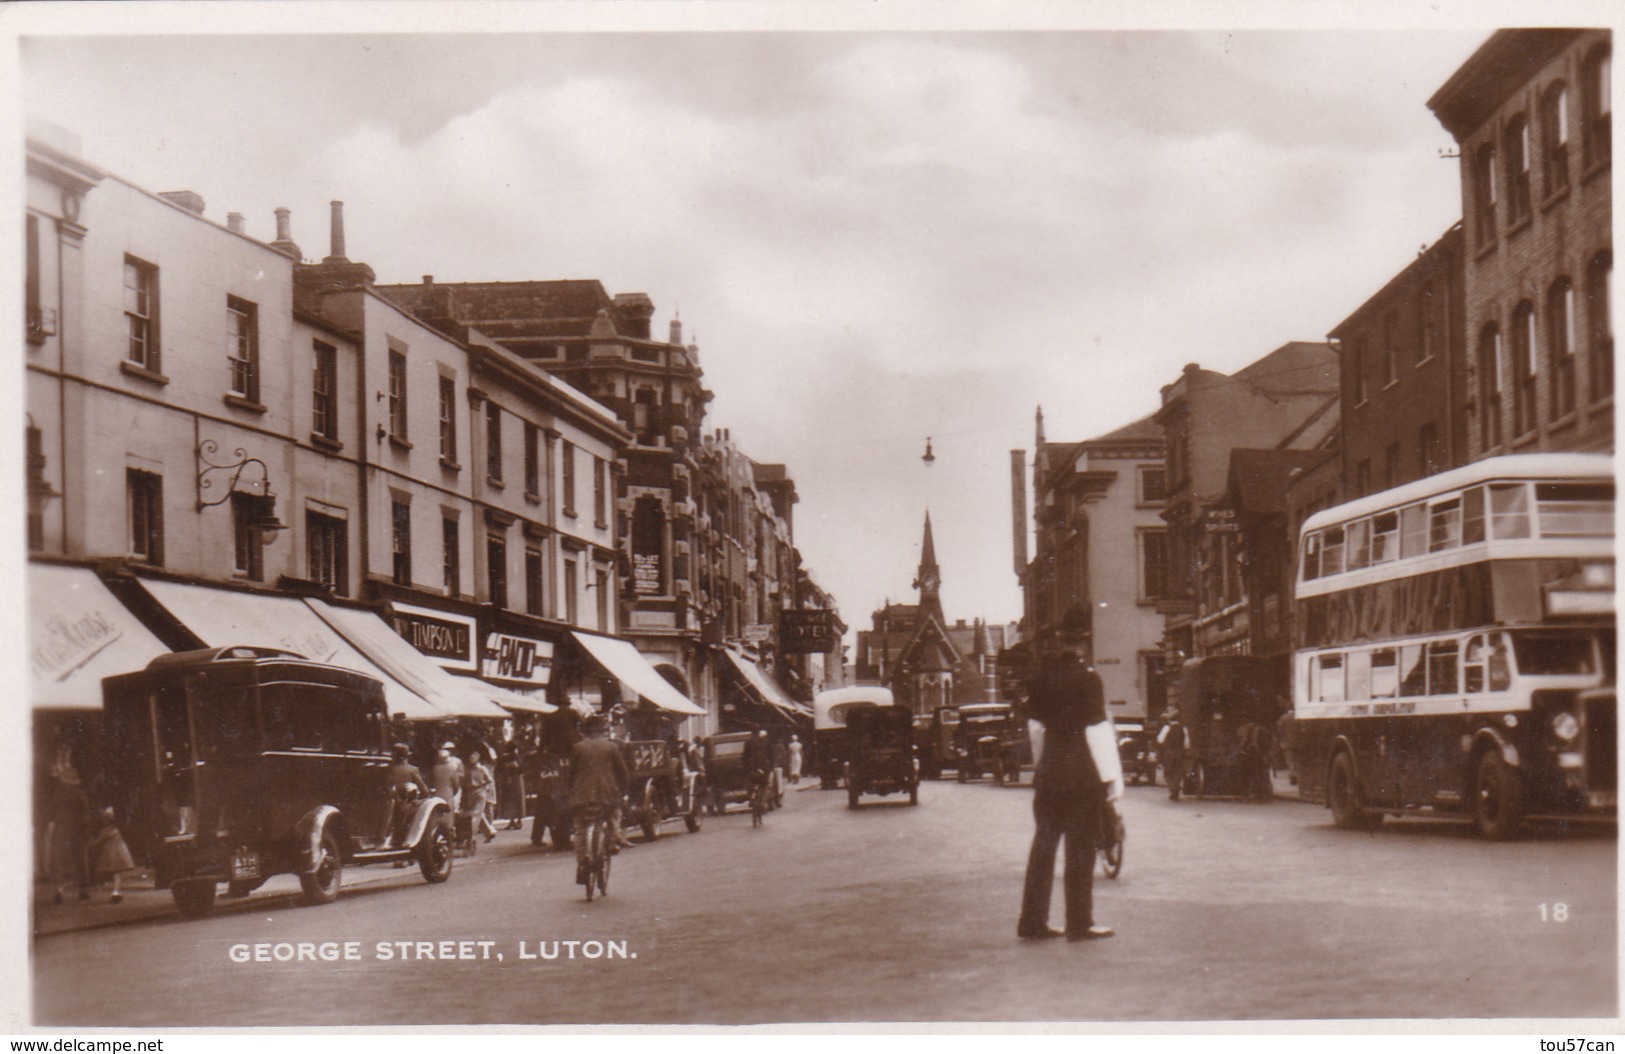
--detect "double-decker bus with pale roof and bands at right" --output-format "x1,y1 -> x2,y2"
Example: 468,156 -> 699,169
1292,453 -> 1617,838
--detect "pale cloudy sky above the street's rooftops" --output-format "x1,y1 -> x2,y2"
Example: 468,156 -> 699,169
11,3 -> 1586,639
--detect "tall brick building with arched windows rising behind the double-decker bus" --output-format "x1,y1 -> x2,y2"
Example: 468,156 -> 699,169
1428,29 -> 1614,461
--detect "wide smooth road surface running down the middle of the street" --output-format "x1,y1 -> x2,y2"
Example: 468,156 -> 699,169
25,776 -> 1619,1026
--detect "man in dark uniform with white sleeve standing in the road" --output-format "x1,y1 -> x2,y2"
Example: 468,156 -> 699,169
1016,629 -> 1123,940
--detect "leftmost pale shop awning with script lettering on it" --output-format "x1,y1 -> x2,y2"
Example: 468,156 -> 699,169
28,564 -> 169,710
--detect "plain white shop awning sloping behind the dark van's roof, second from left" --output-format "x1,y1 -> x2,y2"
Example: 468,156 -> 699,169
141,580 -> 452,721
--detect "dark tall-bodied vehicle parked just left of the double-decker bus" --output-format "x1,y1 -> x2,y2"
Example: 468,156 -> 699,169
1178,654 -> 1281,797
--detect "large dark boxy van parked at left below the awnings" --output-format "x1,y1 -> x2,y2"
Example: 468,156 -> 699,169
102,646 -> 452,916
